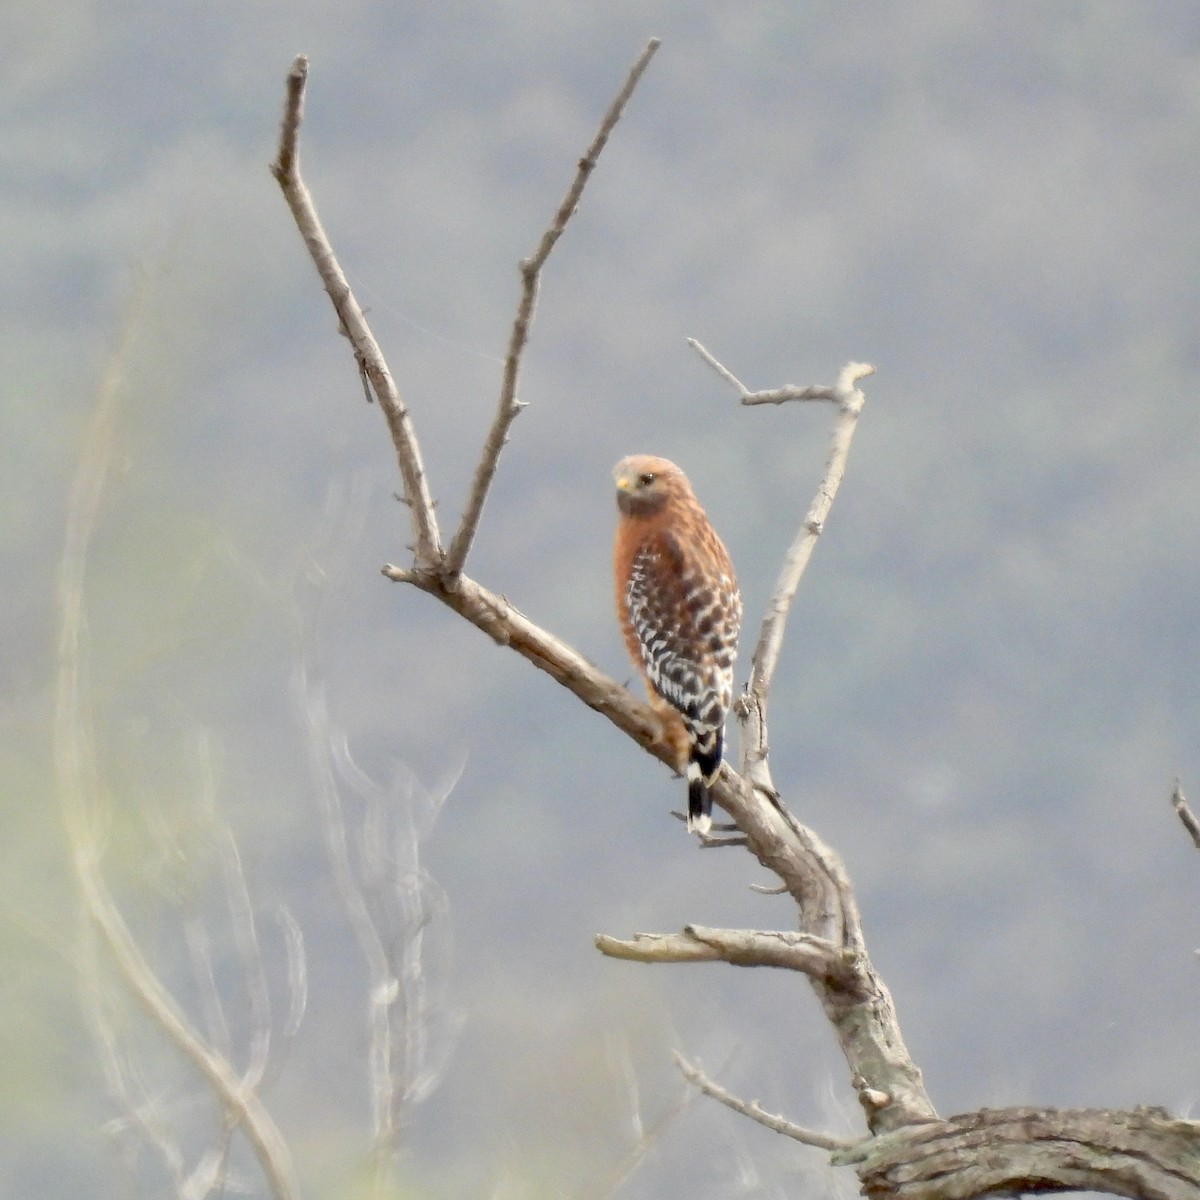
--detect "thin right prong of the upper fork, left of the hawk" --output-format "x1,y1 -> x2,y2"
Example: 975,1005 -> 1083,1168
444,37 -> 659,586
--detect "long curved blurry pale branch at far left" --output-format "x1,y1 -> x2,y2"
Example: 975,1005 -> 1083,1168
54,285 -> 296,1200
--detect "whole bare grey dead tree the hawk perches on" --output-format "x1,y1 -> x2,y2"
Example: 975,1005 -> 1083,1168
272,41 -> 1200,1200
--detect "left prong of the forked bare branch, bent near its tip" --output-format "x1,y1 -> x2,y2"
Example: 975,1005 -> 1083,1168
271,54 -> 442,566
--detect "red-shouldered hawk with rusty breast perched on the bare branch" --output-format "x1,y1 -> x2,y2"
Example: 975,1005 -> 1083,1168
612,455 -> 742,833
